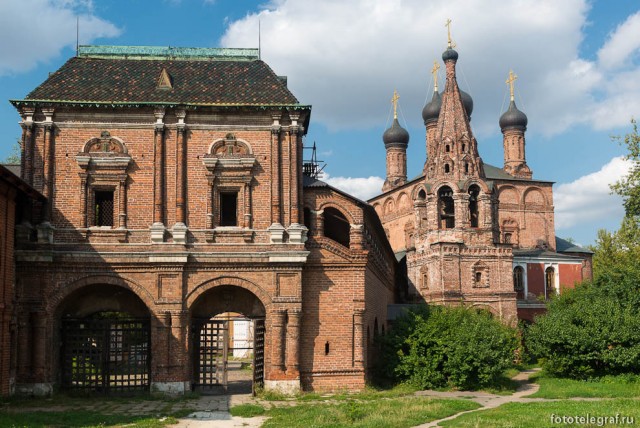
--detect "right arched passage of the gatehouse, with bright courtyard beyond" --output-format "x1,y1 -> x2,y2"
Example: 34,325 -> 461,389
191,285 -> 266,393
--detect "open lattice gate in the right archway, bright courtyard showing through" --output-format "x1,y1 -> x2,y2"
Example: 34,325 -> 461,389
192,318 -> 265,393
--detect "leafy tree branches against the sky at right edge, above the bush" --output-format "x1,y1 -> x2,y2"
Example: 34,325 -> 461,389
611,119 -> 640,217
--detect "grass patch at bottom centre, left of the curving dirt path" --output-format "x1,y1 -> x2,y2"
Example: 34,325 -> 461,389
231,397 -> 479,428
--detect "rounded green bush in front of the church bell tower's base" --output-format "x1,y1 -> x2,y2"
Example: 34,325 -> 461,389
379,306 -> 518,389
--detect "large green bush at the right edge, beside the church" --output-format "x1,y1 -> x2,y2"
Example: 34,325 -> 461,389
525,263 -> 640,379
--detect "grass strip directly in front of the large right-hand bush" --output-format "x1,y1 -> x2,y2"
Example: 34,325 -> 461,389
531,372 -> 640,398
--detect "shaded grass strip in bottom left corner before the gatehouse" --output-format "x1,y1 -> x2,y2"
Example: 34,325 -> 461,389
0,410 -> 185,428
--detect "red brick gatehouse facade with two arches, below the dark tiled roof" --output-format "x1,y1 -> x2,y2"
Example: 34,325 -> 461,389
8,46 -> 395,394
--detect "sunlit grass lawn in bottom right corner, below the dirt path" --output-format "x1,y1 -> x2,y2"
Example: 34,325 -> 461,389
441,398 -> 640,428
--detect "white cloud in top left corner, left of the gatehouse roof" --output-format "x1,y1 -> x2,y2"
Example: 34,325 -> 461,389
0,0 -> 121,75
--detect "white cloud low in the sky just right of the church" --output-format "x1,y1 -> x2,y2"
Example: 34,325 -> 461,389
554,157 -> 632,229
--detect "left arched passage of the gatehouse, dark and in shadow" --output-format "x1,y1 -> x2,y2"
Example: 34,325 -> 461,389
56,284 -> 151,394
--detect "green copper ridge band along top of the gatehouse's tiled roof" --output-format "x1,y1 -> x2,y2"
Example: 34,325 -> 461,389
78,45 -> 259,61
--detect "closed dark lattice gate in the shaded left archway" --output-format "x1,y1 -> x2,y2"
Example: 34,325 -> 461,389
61,318 -> 151,394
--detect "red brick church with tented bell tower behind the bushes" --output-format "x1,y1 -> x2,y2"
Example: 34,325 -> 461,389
369,48 -> 591,324
